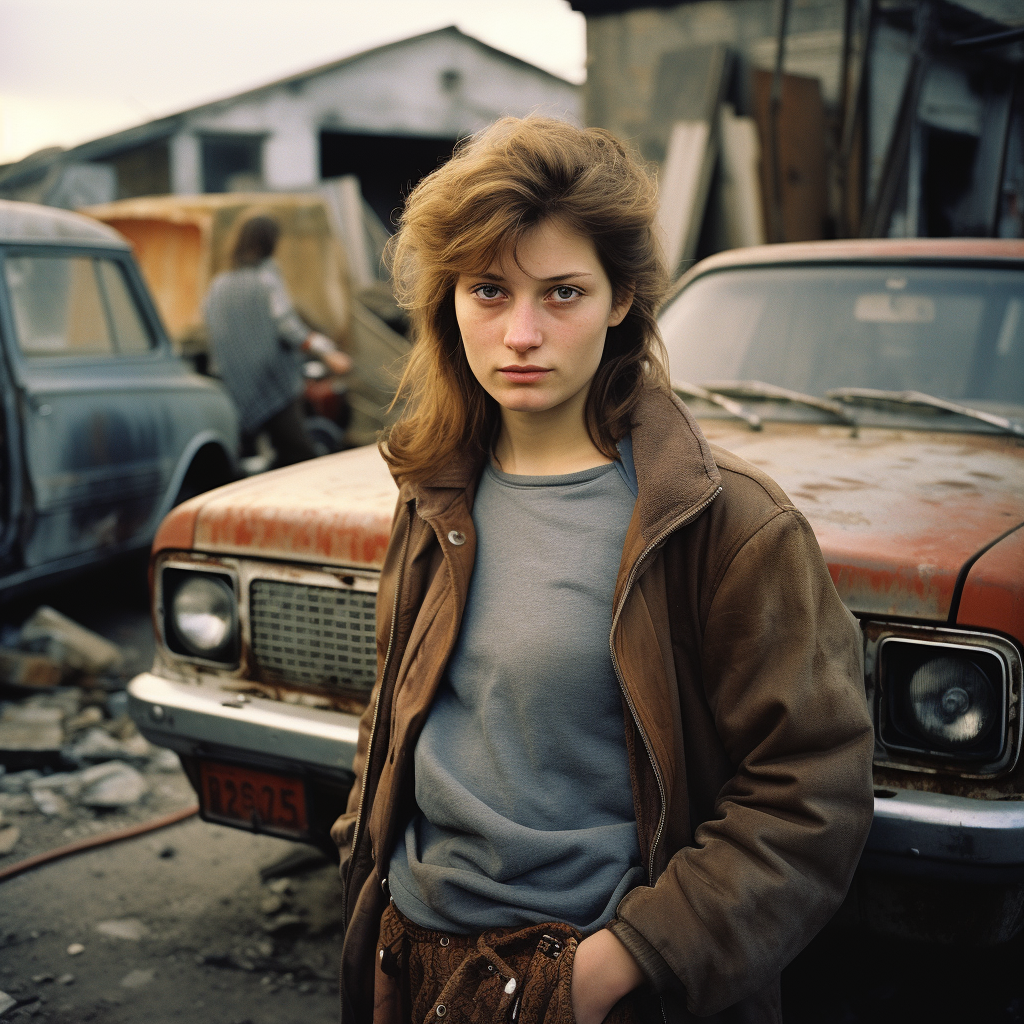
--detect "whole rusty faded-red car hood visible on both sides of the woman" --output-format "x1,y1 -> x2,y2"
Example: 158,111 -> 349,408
154,419 -> 1024,622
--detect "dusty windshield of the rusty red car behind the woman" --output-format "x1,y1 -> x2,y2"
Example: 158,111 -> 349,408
660,264 -> 1024,415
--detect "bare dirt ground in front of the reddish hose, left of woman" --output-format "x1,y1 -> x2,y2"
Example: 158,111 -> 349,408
0,818 -> 341,1024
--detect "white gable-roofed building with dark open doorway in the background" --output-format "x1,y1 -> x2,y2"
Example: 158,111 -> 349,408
0,26 -> 583,223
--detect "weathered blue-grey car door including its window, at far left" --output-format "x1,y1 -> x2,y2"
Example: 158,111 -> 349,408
0,245 -> 173,568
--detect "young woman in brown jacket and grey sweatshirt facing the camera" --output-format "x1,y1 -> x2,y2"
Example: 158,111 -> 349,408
335,118 -> 872,1024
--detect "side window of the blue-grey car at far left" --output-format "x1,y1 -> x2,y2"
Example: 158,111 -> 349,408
4,254 -> 152,356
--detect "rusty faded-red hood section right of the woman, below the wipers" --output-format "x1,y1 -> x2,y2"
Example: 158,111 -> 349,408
701,419 -> 1024,622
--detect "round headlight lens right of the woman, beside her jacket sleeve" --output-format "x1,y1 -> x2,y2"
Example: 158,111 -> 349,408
907,657 -> 999,751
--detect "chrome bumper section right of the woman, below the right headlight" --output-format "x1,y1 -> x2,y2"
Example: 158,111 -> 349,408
861,790 -> 1024,882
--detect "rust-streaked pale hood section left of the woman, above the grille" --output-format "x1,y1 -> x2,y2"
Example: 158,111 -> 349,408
193,446 -> 398,568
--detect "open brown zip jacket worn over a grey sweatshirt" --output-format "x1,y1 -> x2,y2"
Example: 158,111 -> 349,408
335,390 -> 872,1024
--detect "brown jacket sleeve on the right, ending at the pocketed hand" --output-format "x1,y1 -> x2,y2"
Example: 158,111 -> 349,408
609,507 -> 873,1015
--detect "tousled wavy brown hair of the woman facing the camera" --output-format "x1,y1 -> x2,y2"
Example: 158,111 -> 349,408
381,117 -> 669,480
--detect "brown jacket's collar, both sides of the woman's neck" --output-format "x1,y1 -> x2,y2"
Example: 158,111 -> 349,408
391,386 -> 722,543
